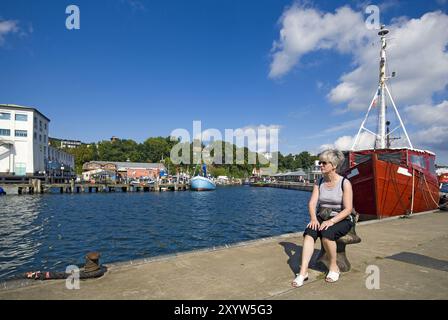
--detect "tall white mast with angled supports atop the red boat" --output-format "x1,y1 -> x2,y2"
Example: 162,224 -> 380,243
351,25 -> 413,151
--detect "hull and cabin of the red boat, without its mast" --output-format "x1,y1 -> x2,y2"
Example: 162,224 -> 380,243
343,148 -> 439,220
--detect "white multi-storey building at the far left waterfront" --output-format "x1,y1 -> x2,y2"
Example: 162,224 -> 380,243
0,104 -> 50,176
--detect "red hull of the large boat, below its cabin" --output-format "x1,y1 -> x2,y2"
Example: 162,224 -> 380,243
346,150 -> 439,220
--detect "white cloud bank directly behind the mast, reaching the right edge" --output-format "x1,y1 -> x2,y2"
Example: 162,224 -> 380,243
328,12 -> 448,110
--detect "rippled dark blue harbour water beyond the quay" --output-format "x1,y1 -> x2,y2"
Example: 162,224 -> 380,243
0,186 -> 310,280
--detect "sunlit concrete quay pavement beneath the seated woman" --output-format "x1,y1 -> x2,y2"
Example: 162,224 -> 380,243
0,211 -> 448,300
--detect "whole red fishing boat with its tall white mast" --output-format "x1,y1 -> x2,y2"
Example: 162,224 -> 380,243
341,26 -> 439,220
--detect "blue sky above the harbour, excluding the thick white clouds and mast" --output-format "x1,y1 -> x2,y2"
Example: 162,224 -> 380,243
0,0 -> 448,164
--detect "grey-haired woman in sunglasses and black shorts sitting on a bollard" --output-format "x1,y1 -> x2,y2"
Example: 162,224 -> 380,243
292,150 -> 354,287
